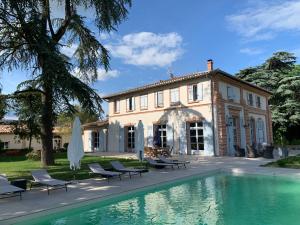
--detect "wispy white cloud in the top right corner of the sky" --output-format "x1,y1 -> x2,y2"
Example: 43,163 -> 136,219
226,1 -> 300,40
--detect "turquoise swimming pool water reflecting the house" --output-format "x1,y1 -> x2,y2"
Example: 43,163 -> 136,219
19,174 -> 300,225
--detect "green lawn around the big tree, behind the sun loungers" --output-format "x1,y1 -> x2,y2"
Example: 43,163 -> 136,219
0,153 -> 142,180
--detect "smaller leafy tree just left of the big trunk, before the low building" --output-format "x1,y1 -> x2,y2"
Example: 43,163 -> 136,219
12,87 -> 42,149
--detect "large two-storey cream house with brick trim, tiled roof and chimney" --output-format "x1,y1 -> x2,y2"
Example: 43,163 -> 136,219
84,60 -> 272,156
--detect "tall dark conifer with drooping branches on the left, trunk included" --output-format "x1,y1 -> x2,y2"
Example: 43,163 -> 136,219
0,0 -> 131,166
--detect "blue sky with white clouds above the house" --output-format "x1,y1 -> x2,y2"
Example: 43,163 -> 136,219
0,0 -> 300,118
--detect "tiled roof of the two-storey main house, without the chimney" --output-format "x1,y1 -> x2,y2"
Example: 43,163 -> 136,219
102,69 -> 271,99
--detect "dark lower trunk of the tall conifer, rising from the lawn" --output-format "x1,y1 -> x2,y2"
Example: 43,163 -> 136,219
41,84 -> 54,166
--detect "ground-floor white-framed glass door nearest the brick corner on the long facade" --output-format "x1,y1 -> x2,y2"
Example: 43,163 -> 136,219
190,121 -> 204,151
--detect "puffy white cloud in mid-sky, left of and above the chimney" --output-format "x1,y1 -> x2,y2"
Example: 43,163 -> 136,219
106,32 -> 183,67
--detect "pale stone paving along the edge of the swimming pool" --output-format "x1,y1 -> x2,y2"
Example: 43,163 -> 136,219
0,156 -> 300,224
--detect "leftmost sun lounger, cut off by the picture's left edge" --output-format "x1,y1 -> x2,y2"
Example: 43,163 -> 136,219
0,175 -> 25,199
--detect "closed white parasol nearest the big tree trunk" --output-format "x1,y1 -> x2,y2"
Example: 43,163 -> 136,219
68,117 -> 84,170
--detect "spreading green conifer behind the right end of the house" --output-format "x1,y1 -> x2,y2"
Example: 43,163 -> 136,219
237,52 -> 300,142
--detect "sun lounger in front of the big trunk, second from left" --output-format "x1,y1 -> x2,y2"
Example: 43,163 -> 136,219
30,170 -> 70,195
